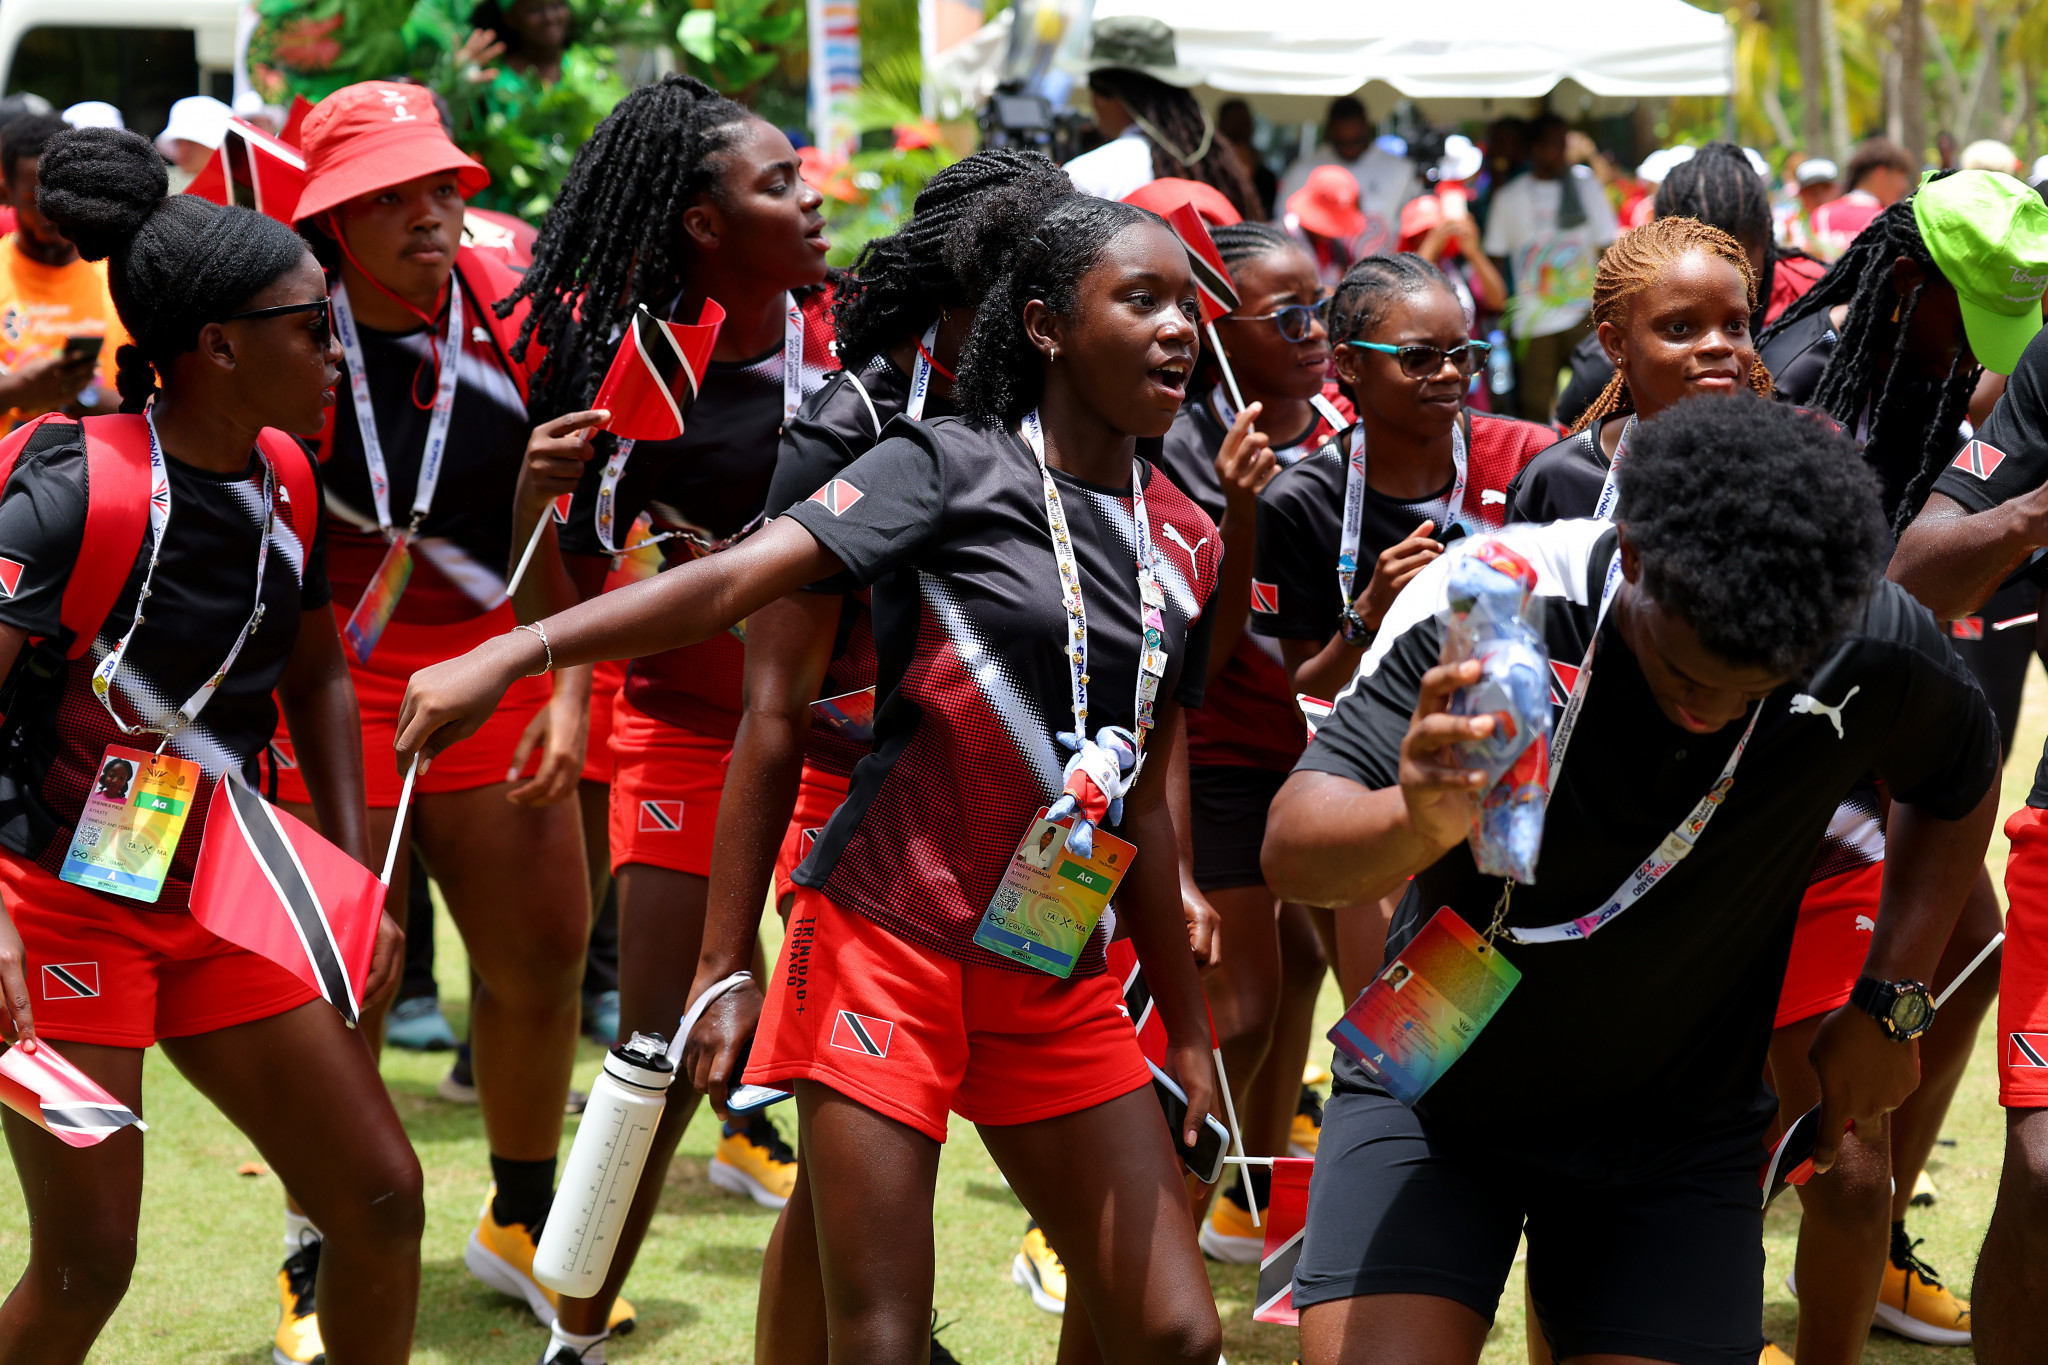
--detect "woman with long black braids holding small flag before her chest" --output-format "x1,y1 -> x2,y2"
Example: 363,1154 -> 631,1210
500,76 -> 834,1361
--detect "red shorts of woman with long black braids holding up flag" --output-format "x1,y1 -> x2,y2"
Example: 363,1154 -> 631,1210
612,696 -> 733,876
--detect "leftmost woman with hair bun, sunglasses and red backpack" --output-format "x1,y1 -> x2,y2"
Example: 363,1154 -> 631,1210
0,129 -> 424,1365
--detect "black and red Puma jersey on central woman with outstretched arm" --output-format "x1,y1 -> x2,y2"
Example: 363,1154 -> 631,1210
788,417 -> 1221,974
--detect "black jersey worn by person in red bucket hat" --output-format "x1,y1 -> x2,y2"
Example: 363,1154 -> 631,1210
322,263 -> 530,626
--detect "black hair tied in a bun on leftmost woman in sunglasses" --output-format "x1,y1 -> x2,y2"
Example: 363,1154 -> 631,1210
37,129 -> 305,413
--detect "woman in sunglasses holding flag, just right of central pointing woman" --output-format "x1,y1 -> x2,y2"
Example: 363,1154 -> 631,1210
1161,223 -> 1352,1263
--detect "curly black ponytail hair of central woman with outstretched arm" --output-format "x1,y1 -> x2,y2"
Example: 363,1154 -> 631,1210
948,194 -> 1165,424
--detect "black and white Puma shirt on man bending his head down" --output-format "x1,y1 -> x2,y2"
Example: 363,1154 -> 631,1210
1300,522 -> 1999,1181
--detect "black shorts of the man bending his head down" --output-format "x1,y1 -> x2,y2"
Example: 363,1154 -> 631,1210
1294,1074 -> 1763,1365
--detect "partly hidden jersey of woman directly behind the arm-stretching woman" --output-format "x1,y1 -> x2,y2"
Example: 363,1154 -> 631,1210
768,356 -> 954,778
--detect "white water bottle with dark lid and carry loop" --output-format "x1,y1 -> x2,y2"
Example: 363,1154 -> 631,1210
532,1033 -> 676,1300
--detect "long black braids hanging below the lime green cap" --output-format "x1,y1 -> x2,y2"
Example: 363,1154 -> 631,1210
1761,185 -> 1982,530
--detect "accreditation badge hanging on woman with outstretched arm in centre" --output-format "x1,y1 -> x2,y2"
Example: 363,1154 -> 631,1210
975,806 -> 1139,980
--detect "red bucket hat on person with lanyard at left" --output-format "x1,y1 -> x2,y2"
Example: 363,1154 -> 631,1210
293,80 -> 492,223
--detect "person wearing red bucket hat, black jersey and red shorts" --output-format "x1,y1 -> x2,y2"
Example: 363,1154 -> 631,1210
260,82 -> 610,1361
